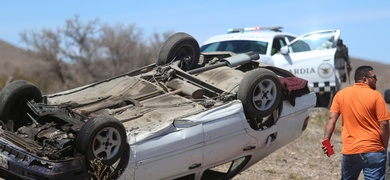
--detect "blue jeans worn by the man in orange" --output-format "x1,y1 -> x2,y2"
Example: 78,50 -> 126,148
341,149 -> 386,180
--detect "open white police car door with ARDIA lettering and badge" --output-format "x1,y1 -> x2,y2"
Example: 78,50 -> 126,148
272,29 -> 340,93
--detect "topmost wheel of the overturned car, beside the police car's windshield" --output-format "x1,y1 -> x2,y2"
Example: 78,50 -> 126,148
157,33 -> 200,71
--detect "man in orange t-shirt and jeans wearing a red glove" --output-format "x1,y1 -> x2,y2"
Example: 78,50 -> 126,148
322,66 -> 390,180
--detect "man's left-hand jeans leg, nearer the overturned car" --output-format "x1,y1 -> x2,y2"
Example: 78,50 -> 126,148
341,154 -> 363,180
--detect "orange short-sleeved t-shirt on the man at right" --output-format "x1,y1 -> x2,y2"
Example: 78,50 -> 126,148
330,83 -> 390,154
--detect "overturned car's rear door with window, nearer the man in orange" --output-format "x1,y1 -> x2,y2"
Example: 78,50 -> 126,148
201,101 -> 257,179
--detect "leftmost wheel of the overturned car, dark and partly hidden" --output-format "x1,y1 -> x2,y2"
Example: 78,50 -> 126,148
0,80 -> 42,131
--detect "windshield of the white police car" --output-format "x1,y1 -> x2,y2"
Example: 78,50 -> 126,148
200,40 -> 268,54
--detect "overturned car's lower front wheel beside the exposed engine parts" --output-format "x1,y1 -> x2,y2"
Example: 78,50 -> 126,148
76,116 -> 127,166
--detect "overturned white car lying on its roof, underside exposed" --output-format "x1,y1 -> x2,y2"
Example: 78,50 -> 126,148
0,33 -> 316,179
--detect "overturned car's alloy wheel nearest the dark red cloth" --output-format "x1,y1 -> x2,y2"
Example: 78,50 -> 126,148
237,69 -> 282,118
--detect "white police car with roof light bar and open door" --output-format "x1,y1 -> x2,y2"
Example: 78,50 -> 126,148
201,26 -> 341,107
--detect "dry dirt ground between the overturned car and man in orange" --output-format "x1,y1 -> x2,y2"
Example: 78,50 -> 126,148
233,108 -> 363,180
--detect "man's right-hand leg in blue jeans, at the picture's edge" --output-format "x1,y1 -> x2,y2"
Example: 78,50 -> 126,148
362,150 -> 386,180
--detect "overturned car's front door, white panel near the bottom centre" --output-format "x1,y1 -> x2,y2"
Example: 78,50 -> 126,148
133,124 -> 204,179
